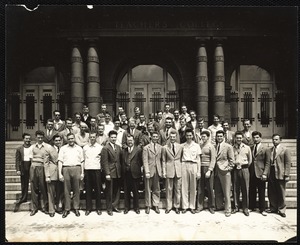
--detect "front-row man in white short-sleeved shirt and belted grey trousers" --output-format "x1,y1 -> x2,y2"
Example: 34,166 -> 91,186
58,133 -> 84,218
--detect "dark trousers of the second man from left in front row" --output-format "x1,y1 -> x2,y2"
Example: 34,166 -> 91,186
30,165 -> 48,211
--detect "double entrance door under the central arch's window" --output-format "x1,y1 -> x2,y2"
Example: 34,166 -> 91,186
129,82 -> 165,119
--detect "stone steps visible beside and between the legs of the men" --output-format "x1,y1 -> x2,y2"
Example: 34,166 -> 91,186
5,139 -> 297,211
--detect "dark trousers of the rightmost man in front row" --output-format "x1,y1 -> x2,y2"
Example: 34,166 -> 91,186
268,167 -> 286,213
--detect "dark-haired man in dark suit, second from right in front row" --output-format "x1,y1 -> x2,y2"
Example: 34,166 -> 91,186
249,131 -> 270,216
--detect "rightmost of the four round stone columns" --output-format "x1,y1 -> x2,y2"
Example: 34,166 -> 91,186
213,42 -> 225,120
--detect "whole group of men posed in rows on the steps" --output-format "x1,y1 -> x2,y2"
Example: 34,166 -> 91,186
16,104 -> 291,218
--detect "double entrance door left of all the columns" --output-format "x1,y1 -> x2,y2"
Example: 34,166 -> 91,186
21,85 -> 56,138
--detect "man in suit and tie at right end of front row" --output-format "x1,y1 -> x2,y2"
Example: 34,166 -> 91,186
268,134 -> 291,217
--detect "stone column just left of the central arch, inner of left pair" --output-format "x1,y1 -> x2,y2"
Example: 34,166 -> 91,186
87,42 -> 101,116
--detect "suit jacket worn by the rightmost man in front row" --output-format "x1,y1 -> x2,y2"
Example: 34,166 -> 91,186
269,144 -> 291,180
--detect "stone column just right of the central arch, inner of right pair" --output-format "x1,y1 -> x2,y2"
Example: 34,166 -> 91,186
196,42 -> 208,123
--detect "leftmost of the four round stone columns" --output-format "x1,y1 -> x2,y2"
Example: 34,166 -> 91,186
71,44 -> 84,114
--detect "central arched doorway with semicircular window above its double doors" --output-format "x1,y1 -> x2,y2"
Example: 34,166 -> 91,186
117,64 -> 179,118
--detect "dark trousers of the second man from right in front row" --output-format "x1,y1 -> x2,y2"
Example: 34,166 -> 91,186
249,173 -> 266,212
